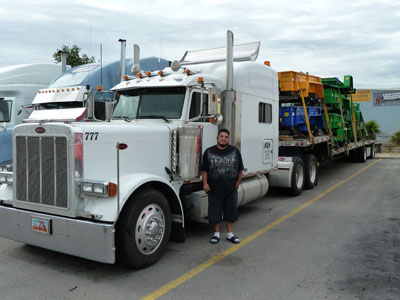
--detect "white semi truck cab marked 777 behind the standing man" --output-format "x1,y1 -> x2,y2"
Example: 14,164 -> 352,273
0,31 -> 279,268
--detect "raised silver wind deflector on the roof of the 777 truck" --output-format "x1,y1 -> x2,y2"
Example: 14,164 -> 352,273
179,42 -> 260,65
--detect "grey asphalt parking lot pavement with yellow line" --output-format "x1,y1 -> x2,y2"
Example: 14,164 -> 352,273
0,158 -> 400,300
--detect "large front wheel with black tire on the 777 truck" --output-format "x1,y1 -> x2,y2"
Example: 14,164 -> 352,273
116,189 -> 171,269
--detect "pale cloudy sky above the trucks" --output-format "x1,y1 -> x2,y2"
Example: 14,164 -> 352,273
0,0 -> 400,89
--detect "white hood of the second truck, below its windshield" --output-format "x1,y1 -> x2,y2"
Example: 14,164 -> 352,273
24,107 -> 87,123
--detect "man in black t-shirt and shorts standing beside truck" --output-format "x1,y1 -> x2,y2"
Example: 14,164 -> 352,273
202,129 -> 243,244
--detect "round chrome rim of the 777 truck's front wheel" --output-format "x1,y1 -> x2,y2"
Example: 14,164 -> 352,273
135,204 -> 165,255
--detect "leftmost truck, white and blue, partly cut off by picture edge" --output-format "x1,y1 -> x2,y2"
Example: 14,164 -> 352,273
0,63 -> 62,170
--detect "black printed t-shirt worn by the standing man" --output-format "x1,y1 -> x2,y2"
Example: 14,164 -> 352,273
202,145 -> 244,196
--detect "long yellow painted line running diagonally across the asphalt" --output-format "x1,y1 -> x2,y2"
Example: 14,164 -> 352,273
142,159 -> 382,300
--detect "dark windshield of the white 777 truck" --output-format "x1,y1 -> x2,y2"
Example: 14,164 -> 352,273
113,87 -> 186,119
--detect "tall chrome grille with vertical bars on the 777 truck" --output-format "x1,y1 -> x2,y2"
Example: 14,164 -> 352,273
16,136 -> 68,208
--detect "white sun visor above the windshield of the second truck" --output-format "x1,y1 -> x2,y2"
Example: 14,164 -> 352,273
33,86 -> 87,104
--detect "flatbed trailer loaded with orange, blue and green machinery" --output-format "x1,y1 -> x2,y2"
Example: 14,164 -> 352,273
269,71 -> 375,196
